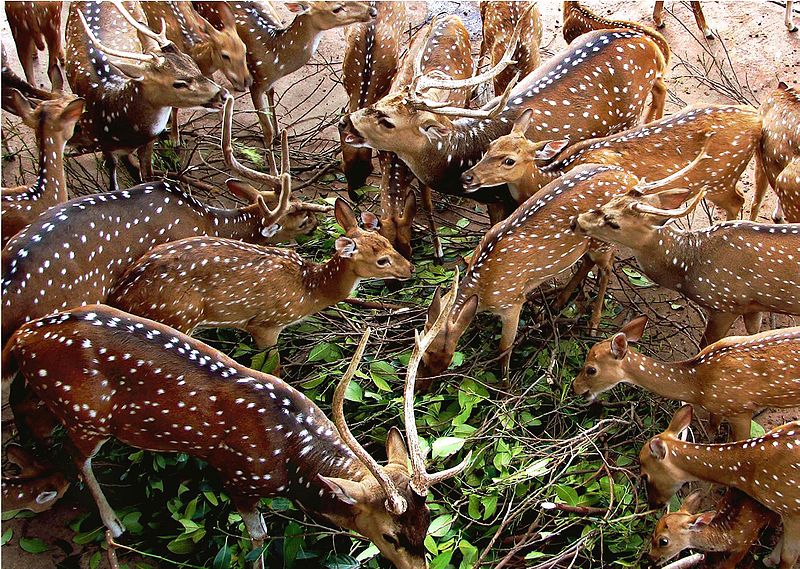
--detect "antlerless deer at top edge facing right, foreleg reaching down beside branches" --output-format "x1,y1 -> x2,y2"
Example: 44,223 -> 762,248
194,1 -> 377,173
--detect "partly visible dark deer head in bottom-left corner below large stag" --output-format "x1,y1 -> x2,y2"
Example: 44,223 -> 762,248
2,444 -> 69,514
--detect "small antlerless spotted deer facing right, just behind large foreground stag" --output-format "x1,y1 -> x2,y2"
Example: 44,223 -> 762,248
108,199 -> 412,349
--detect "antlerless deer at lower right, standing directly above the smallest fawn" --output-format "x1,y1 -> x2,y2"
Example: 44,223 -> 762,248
639,405 -> 800,569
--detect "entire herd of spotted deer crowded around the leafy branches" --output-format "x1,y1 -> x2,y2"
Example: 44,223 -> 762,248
2,0 -> 800,569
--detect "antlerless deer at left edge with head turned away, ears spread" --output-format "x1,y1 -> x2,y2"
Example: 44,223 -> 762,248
2,90 -> 83,247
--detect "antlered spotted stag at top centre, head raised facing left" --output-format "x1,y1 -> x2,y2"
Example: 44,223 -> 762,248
340,26 -> 666,213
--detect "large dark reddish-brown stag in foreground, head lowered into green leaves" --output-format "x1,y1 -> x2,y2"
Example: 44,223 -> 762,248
3,290 -> 470,569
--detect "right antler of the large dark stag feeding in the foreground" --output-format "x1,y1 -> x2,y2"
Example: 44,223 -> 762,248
403,270 -> 472,496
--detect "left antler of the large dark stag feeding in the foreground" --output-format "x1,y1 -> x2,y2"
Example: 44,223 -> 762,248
333,328 -> 408,516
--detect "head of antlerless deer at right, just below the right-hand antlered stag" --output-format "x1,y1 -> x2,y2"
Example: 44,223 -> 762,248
572,316 -> 647,402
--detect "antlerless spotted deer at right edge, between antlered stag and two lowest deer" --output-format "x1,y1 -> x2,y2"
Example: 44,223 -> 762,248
572,316 -> 800,441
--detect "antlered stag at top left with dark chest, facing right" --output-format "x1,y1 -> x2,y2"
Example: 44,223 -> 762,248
67,0 -> 223,191
